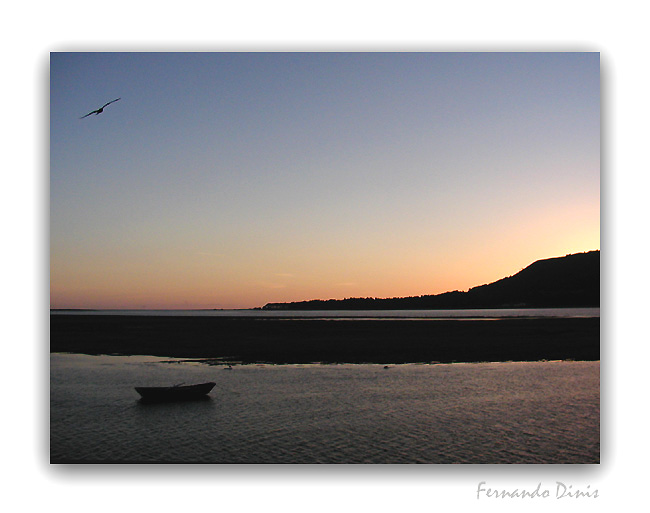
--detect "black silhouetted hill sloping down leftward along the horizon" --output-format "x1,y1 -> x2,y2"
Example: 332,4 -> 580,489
263,251 -> 600,310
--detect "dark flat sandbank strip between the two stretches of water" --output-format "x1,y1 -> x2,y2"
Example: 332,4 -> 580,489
50,314 -> 600,364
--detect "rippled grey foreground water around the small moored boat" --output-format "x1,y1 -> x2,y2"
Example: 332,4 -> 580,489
50,354 -> 600,463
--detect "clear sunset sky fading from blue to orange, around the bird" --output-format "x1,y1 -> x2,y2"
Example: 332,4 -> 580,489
50,53 -> 600,309
